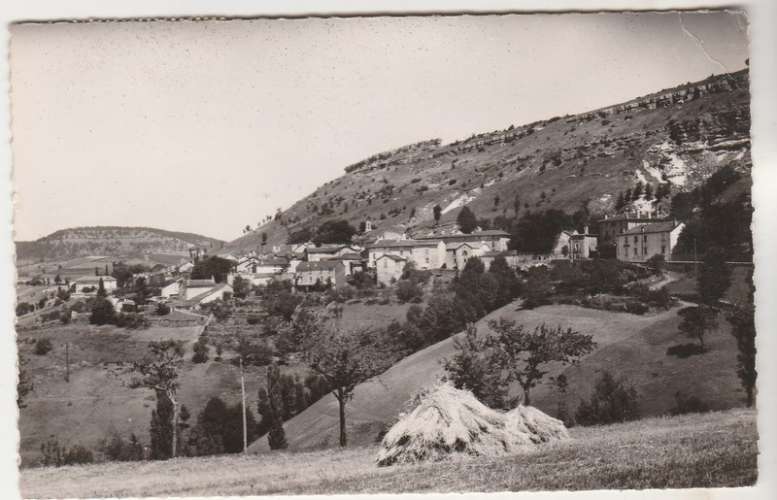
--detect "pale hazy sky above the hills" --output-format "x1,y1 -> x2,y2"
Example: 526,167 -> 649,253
11,9 -> 748,240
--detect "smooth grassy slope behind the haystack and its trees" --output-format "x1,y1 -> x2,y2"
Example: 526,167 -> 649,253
249,292 -> 743,453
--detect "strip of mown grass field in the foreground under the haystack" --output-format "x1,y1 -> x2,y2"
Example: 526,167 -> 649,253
21,409 -> 758,498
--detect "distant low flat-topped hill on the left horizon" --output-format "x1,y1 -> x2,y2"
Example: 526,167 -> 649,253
16,226 -> 223,264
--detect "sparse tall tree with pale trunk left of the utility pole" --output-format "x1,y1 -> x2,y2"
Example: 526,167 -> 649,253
133,340 -> 184,457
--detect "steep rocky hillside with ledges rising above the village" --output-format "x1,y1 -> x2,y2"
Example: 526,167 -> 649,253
227,70 -> 751,252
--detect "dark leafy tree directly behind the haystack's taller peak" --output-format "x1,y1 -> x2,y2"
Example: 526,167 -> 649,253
443,323 -> 514,409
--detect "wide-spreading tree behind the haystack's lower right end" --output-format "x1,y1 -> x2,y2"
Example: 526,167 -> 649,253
488,318 -> 596,406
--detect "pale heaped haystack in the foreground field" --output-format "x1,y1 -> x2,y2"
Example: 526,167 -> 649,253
377,383 -> 569,465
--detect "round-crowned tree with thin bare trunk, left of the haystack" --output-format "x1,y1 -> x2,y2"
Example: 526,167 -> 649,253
303,325 -> 382,447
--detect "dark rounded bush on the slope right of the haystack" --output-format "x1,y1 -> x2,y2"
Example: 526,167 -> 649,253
575,371 -> 640,425
